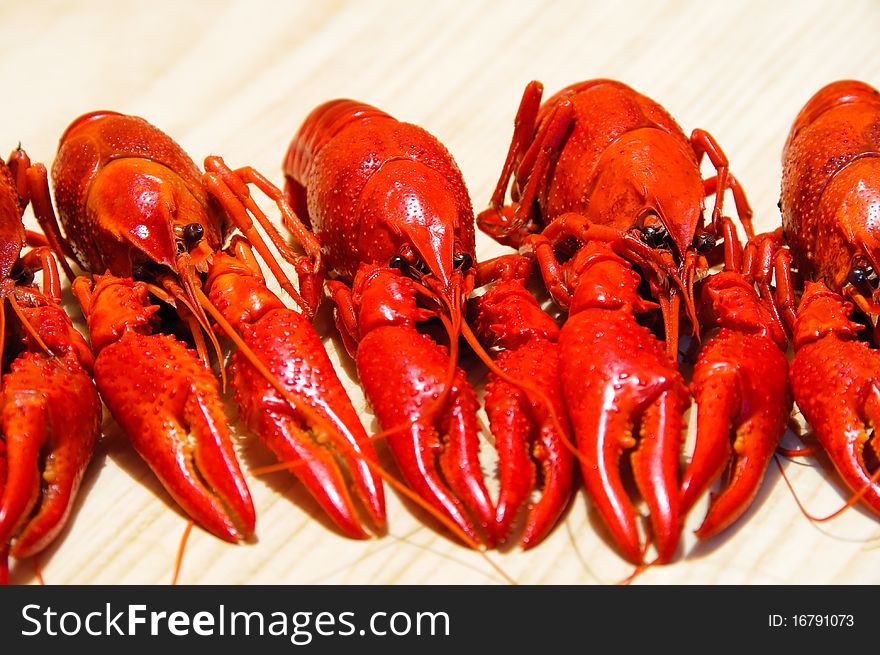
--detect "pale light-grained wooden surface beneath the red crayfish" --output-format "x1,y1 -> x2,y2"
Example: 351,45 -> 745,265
0,0 -> 880,584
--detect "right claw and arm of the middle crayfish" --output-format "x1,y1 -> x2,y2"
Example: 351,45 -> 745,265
473,274 -> 574,548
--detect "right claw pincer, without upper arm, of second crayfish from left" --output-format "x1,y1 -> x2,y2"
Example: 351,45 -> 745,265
231,308 -> 385,539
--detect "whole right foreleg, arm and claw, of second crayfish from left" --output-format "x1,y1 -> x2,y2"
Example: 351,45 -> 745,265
206,249 -> 385,539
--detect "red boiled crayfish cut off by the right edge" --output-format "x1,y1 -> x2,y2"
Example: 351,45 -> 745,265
779,80 -> 880,514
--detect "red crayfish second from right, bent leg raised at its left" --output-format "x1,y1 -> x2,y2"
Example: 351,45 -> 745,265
477,80 -> 787,562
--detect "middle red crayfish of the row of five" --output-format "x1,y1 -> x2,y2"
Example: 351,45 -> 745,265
284,100 -> 572,546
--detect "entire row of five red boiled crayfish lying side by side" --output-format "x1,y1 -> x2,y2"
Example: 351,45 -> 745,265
0,80 -> 880,579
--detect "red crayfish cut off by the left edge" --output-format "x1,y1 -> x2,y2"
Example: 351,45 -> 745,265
0,149 -> 101,583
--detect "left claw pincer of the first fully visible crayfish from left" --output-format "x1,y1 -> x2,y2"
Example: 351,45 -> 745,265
95,332 -> 256,542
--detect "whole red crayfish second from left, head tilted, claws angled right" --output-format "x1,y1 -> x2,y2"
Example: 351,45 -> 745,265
29,112 -> 385,541
